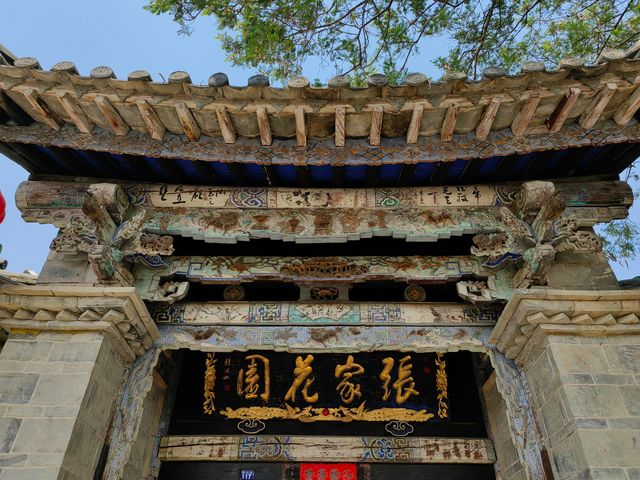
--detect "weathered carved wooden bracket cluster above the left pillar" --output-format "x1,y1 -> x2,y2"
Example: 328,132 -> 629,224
51,183 -> 173,285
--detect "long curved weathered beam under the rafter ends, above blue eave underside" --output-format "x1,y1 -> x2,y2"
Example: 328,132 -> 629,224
0,120 -> 640,166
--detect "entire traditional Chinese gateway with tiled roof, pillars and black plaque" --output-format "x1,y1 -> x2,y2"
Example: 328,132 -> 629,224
0,43 -> 640,480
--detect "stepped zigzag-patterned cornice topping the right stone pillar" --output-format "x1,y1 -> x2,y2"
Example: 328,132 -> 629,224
489,289 -> 640,366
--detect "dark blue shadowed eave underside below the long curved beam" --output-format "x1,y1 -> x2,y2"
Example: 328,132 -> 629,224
5,139 -> 640,188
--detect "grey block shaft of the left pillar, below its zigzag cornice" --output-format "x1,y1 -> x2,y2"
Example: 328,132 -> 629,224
0,332 -> 124,480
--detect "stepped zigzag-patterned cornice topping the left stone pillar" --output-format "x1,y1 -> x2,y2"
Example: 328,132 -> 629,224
0,285 -> 159,360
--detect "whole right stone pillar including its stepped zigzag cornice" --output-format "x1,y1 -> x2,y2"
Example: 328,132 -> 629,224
492,289 -> 640,480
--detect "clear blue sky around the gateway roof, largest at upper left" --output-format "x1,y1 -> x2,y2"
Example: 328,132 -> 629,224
0,0 -> 640,279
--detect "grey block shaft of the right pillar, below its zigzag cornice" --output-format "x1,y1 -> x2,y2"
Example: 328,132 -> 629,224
525,335 -> 640,480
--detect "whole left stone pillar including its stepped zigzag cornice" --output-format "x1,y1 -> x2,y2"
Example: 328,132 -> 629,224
0,287 -> 157,480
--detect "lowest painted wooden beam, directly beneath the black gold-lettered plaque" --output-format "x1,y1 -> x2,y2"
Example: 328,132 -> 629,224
159,435 -> 496,464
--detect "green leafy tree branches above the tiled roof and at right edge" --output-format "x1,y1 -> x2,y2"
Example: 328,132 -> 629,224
145,0 -> 640,261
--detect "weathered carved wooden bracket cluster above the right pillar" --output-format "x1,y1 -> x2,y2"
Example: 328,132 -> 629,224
471,181 -> 602,288
